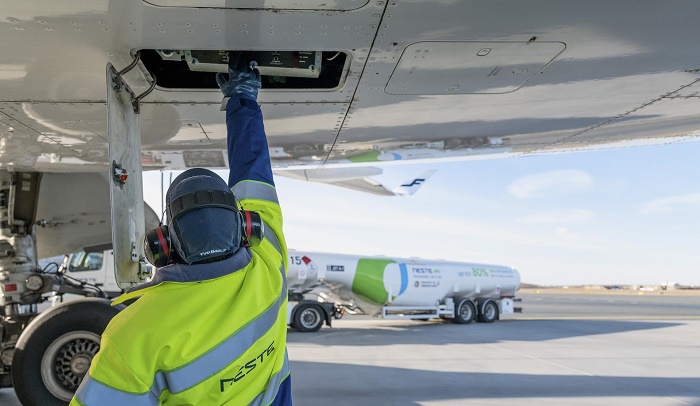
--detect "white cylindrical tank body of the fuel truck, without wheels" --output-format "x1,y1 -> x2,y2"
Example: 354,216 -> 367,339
288,251 -> 520,306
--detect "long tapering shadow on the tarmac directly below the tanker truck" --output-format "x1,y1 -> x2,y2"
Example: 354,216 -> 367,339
287,320 -> 683,346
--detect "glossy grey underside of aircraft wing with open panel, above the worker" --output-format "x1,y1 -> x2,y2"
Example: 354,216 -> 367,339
0,0 -> 700,172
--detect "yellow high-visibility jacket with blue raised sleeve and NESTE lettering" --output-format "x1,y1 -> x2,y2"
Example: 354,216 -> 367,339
71,99 -> 291,406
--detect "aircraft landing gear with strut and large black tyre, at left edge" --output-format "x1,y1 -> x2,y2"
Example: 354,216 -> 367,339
0,170 -> 119,406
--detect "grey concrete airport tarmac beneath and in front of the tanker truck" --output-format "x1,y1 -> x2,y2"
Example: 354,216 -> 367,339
0,292 -> 700,406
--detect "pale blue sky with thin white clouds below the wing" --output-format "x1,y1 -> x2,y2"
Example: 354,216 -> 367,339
144,142 -> 700,285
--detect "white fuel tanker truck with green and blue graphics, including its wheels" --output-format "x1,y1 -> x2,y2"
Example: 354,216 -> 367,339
288,250 -> 520,332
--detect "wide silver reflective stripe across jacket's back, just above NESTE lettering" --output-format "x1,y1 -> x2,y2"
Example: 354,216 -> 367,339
76,267 -> 287,406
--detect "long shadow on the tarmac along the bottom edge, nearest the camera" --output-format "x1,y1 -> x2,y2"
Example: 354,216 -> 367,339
291,361 -> 700,406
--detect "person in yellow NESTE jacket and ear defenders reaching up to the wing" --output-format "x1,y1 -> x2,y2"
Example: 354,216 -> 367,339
71,54 -> 292,406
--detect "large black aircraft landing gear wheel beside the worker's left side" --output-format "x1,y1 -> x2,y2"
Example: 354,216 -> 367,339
12,299 -> 123,406
